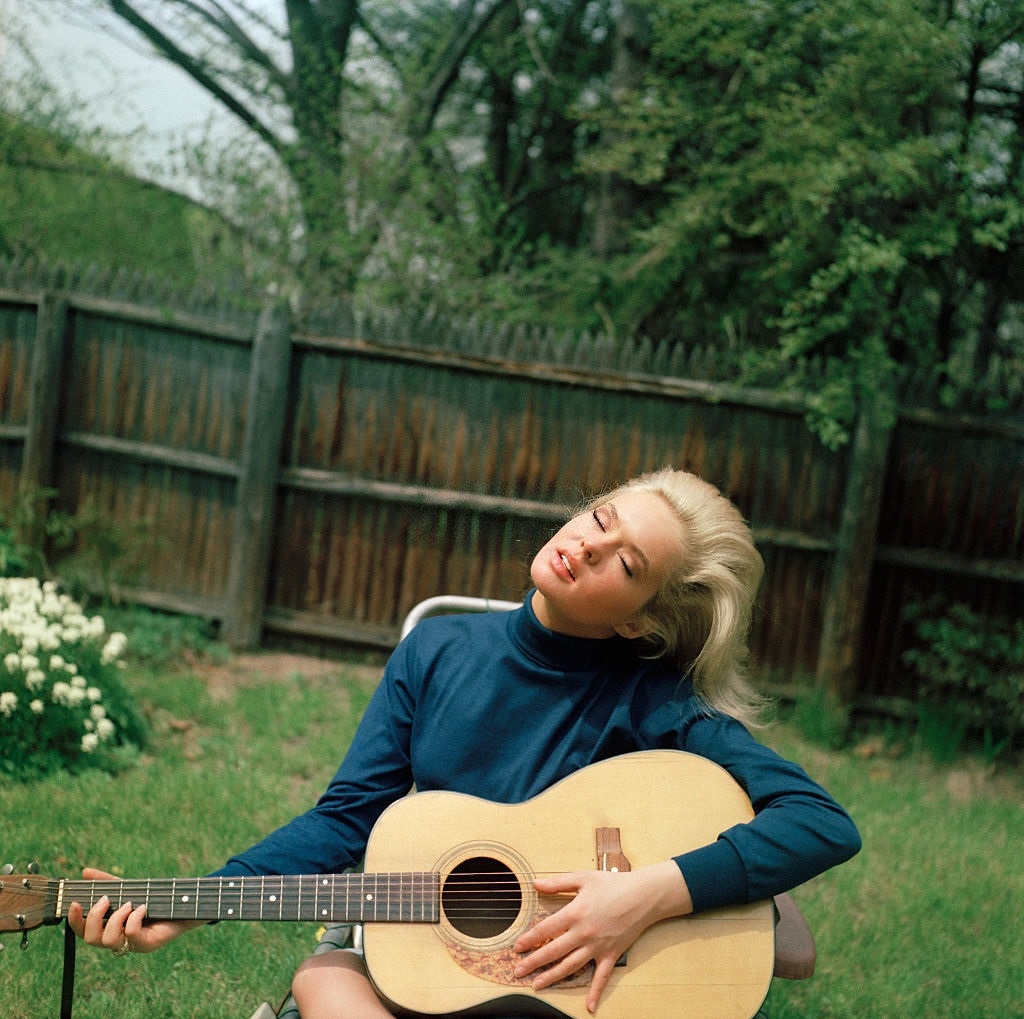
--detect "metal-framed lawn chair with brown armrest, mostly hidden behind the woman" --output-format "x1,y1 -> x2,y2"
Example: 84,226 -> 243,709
251,595 -> 817,1019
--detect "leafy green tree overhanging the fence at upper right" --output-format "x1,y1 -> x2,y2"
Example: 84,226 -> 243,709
592,0 -> 1024,442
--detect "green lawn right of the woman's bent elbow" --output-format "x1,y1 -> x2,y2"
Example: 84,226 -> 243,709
765,730 -> 1024,1019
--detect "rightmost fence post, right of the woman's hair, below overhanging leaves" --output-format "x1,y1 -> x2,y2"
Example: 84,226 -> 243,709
817,379 -> 896,704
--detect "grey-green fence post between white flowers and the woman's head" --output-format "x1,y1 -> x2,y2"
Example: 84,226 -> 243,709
221,304 -> 292,650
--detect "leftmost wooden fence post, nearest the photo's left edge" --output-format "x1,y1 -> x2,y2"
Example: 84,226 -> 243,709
18,292 -> 69,536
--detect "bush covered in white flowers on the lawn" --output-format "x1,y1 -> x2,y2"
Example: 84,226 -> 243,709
0,577 -> 145,777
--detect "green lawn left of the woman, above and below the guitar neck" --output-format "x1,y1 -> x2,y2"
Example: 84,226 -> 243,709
0,663 -> 372,1019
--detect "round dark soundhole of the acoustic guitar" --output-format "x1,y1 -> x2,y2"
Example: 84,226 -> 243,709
441,856 -> 522,939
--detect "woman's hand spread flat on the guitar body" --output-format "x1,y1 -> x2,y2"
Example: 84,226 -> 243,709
513,860 -> 693,1013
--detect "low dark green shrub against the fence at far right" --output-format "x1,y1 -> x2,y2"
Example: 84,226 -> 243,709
902,601 -> 1024,758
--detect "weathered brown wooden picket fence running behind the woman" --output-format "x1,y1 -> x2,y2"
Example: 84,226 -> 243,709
0,266 -> 1024,697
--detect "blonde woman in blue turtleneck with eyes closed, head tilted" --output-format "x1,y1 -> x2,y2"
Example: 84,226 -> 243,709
70,470 -> 860,1019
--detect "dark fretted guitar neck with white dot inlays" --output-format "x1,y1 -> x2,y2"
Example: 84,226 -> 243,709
46,873 -> 440,924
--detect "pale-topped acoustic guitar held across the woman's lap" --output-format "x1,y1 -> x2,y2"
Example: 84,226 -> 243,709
0,751 -> 774,1019
